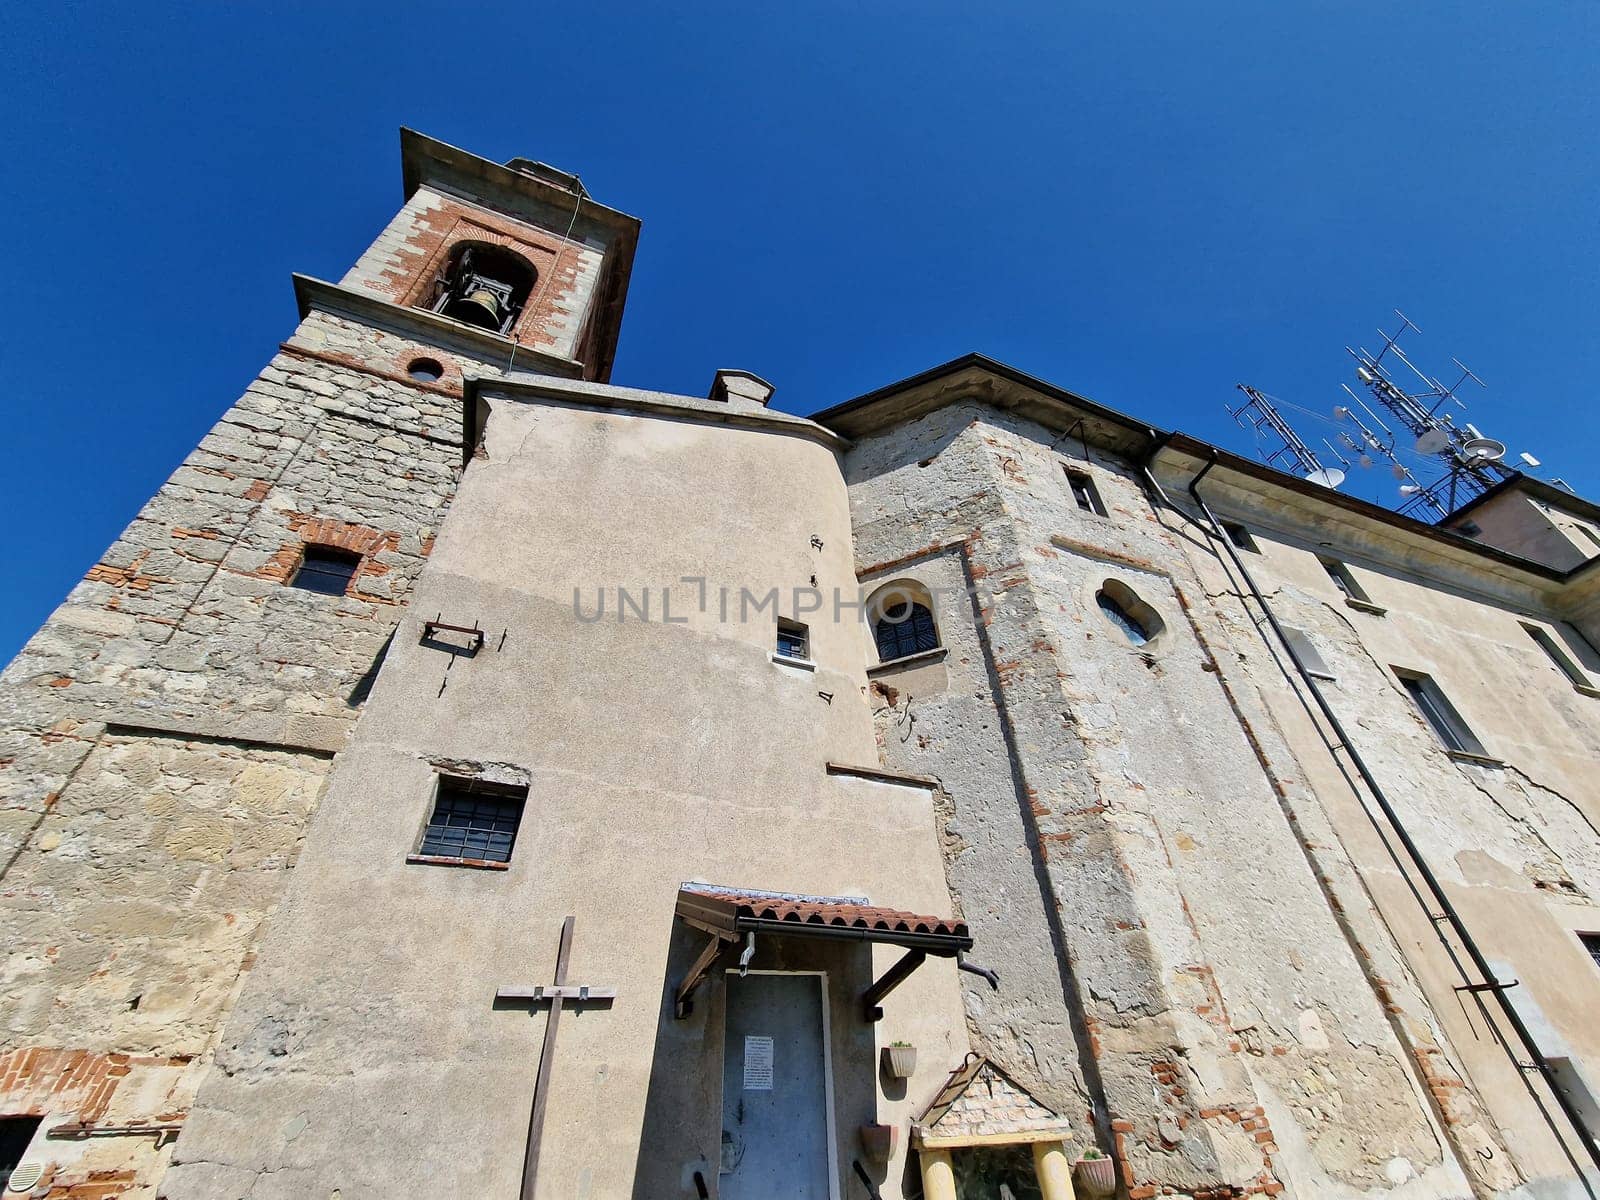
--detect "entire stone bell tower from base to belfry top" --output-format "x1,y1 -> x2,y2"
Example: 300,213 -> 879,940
0,130 -> 638,1195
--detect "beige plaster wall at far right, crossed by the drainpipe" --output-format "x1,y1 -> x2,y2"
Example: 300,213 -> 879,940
1171,492 -> 1600,1197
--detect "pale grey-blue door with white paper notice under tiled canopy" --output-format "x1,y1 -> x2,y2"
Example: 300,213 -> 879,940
718,974 -> 832,1200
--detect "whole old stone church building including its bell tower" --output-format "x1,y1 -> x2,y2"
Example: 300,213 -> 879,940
0,131 -> 1600,1200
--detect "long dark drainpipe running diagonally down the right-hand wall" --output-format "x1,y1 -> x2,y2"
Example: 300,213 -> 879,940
1158,448 -> 1600,1170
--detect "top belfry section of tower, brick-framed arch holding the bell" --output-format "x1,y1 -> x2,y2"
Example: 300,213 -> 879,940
294,130 -> 638,382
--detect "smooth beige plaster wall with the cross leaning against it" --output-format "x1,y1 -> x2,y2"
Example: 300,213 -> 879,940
166,389 -> 965,1200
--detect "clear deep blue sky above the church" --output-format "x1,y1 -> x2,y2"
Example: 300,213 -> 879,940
0,0 -> 1600,661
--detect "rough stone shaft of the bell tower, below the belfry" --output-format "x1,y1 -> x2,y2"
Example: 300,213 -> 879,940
0,305 -> 473,1198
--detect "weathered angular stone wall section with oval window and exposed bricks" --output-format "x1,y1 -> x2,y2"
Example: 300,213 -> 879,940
850,405 -> 1467,1198
